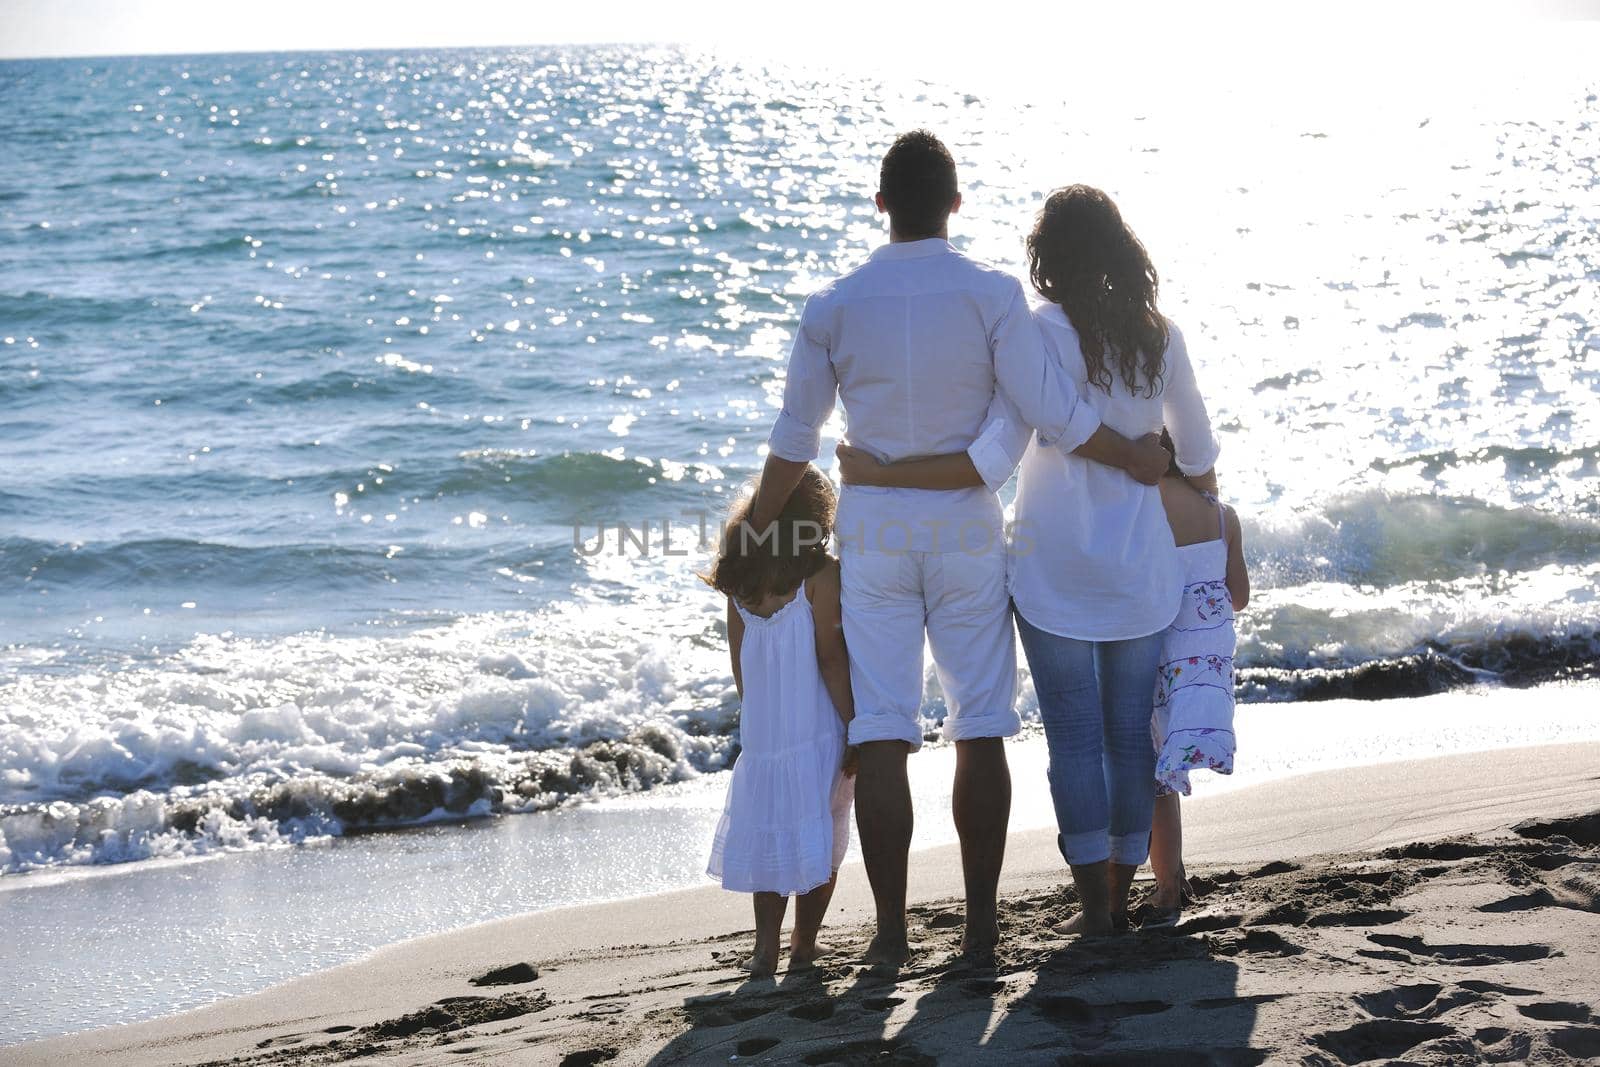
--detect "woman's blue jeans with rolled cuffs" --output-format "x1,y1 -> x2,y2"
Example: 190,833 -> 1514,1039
1016,613 -> 1162,867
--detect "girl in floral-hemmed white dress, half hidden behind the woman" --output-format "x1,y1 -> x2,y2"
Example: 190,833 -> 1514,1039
1144,435 -> 1250,926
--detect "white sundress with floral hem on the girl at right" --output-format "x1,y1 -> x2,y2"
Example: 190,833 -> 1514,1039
1150,494 -> 1237,797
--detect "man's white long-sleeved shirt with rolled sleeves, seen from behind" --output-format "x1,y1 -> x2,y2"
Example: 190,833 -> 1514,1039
768,237 -> 1099,552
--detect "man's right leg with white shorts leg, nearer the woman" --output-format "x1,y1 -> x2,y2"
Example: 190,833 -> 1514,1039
923,537 -> 1021,958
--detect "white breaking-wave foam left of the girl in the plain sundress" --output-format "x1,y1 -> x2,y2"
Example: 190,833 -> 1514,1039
0,606 -> 733,872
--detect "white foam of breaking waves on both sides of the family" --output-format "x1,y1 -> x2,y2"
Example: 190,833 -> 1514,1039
0,550 -> 1600,873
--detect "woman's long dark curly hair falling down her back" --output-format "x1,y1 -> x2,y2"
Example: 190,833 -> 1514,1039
1027,186 -> 1166,397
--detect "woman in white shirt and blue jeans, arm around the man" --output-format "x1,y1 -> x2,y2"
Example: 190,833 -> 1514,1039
840,186 -> 1218,934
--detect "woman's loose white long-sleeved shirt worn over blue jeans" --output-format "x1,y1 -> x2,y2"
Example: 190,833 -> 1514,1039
968,304 -> 1219,641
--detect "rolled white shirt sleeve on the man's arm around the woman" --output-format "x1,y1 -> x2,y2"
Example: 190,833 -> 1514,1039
989,283 -> 1101,451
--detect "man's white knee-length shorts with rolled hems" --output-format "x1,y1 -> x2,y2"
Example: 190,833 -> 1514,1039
840,542 -> 1022,749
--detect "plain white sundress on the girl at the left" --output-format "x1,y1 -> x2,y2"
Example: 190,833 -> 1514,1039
706,585 -> 856,896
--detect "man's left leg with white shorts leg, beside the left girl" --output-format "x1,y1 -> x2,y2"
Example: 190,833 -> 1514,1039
840,550 -> 923,966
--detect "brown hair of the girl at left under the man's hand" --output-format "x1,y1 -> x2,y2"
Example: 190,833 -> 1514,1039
706,464 -> 835,605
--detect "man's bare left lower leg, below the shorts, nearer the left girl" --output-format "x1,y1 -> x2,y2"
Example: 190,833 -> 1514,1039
856,741 -> 912,965
